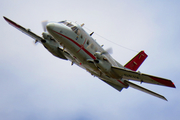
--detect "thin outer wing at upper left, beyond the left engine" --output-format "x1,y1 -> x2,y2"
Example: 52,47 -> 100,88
4,17 -> 44,42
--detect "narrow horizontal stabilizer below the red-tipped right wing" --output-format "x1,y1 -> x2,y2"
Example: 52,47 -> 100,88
126,81 -> 167,101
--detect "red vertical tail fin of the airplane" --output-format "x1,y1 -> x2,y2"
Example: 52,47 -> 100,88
124,51 -> 148,71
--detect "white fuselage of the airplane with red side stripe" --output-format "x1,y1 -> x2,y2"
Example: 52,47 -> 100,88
46,21 -> 126,87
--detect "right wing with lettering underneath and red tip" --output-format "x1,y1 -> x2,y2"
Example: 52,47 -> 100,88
112,67 -> 175,88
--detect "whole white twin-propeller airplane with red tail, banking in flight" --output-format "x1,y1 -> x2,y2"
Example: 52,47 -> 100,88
3,16 -> 176,101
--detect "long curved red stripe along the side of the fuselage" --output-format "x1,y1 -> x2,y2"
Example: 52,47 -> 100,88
53,30 -> 96,60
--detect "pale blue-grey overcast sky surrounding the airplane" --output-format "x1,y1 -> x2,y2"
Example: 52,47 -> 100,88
0,0 -> 180,120
